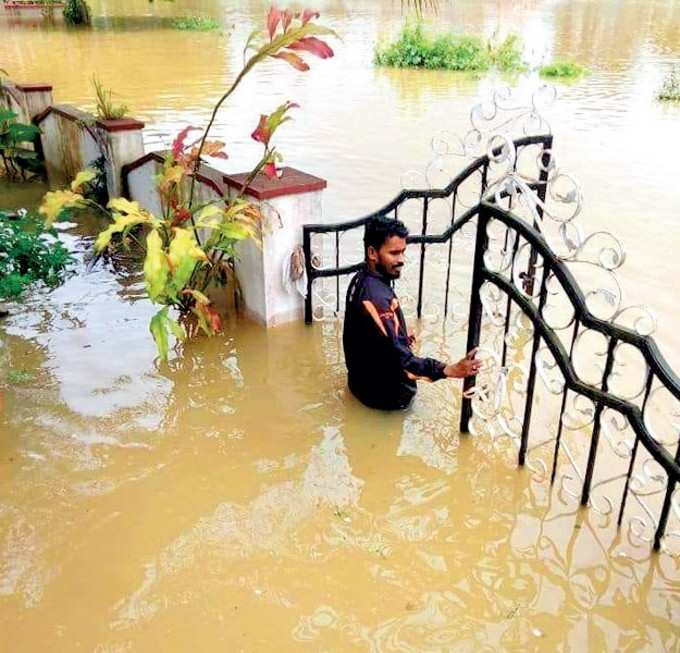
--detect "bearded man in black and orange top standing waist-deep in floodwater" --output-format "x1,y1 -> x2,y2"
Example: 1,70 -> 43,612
343,217 -> 481,410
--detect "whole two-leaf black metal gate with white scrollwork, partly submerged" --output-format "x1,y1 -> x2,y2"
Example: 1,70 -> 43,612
303,136 -> 680,550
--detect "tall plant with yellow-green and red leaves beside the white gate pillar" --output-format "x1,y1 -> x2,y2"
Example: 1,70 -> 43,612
40,7 -> 334,360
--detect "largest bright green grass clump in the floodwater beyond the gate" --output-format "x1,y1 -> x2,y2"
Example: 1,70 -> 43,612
374,23 -> 523,72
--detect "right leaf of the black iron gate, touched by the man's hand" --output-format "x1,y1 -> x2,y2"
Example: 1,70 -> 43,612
461,202 -> 680,550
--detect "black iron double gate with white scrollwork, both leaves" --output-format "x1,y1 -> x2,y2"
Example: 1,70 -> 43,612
303,136 -> 680,550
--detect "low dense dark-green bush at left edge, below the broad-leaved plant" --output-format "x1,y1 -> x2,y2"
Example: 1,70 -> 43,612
0,212 -> 72,299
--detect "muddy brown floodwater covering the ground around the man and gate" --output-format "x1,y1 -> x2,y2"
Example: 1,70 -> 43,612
0,0 -> 680,653
